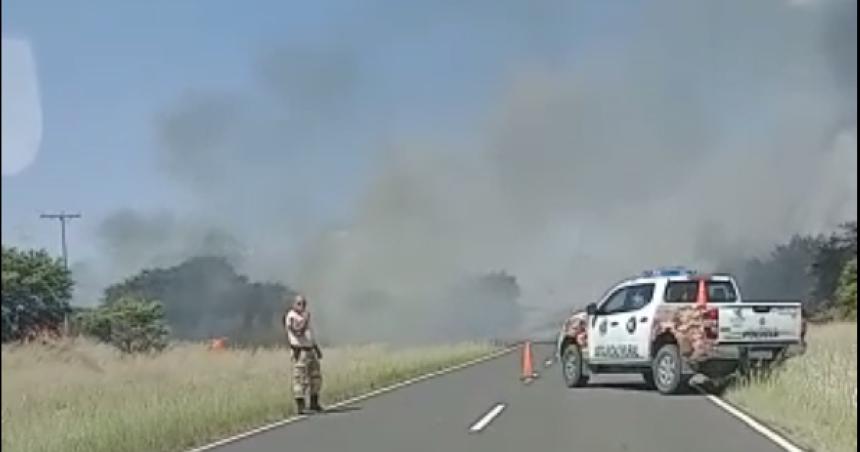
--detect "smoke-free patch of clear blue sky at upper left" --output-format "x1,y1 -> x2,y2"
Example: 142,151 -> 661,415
2,1 -> 362,258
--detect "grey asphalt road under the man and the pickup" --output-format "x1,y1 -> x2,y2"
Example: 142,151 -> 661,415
215,346 -> 782,452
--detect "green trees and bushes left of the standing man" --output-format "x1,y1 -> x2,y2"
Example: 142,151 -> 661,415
2,246 -> 294,352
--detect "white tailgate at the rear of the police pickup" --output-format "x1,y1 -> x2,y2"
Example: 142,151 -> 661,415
718,303 -> 802,344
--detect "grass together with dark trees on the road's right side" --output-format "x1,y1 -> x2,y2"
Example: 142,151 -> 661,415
725,222 -> 857,452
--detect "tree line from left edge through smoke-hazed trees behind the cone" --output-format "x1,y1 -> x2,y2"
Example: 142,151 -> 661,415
2,246 -> 522,353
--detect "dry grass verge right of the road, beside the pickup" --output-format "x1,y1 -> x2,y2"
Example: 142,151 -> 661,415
725,323 -> 857,452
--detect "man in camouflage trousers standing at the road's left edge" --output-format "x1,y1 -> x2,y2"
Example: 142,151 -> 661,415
284,295 -> 323,414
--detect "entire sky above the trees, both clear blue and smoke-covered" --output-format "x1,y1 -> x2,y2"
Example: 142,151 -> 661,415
2,0 -> 856,314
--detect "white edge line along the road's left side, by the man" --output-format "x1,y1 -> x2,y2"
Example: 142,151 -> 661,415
185,344 -> 519,452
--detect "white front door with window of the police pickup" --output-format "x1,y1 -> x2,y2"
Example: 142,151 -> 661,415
588,283 -> 654,363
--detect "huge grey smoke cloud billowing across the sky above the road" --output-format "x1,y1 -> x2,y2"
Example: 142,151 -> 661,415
85,0 -> 857,340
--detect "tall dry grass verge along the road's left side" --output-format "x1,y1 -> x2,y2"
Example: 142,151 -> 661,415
2,341 -> 493,452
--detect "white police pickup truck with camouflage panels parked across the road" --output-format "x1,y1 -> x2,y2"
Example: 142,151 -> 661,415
557,267 -> 806,394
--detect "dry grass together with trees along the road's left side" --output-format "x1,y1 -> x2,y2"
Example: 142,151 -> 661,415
2,246 -> 500,452
